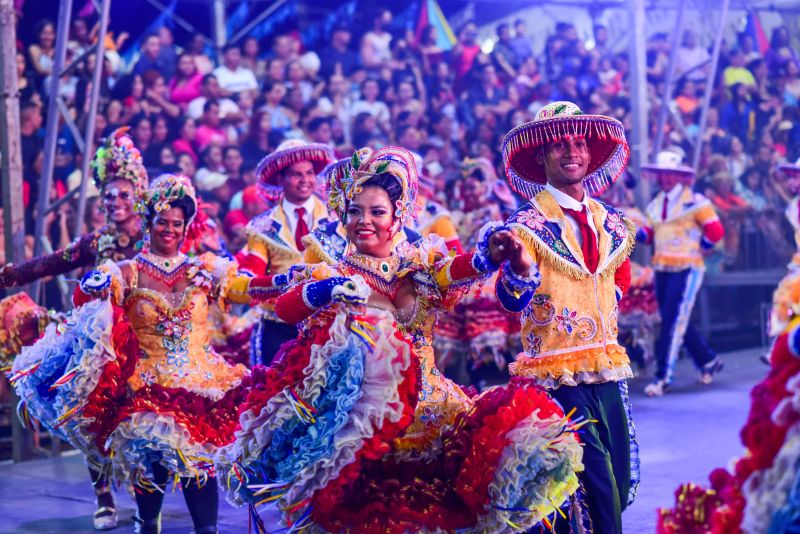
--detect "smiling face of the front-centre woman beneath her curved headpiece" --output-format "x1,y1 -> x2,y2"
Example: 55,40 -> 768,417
345,185 -> 397,258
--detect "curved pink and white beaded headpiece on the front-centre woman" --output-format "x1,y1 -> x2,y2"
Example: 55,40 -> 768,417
328,146 -> 419,225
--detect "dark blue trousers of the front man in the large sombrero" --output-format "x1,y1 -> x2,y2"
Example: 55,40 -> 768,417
550,382 -> 631,534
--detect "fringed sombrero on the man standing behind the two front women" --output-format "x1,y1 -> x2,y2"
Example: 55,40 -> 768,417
256,139 -> 335,200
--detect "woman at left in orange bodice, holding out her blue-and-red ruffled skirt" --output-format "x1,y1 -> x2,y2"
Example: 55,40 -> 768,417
12,175 -> 294,534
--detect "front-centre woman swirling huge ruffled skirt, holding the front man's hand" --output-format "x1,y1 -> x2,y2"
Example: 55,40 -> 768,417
217,147 -> 582,533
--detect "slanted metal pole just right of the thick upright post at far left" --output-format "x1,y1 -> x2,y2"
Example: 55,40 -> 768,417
31,0 -> 72,299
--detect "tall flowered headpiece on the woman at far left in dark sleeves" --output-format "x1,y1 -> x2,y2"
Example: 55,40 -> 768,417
92,126 -> 148,214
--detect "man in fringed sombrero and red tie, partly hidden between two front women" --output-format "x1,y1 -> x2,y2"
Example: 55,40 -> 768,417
237,139 -> 334,365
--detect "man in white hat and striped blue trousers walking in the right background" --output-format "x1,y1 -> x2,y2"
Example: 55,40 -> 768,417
639,150 -> 725,397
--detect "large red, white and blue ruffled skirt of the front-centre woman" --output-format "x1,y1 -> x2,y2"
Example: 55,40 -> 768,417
216,309 -> 582,533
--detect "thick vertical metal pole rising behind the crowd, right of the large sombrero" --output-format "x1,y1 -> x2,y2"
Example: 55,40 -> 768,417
628,0 -> 650,206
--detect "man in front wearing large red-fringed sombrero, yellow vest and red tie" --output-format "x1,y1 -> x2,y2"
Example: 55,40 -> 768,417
496,102 -> 638,534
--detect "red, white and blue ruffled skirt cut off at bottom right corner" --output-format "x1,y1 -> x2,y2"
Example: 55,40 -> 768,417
659,330 -> 800,534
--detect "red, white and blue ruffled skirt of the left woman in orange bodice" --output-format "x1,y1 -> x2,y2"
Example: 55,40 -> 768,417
12,301 -> 256,480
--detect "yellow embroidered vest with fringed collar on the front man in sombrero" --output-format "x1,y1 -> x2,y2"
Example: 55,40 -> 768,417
508,191 -> 635,388
